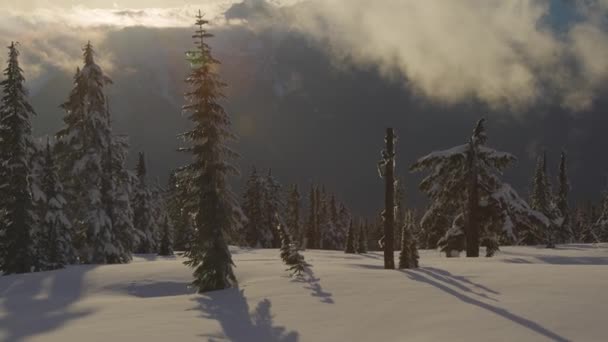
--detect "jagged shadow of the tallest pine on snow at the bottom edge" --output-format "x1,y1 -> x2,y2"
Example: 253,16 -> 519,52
195,288 -> 299,342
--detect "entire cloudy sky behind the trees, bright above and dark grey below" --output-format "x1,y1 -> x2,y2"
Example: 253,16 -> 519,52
0,0 -> 608,214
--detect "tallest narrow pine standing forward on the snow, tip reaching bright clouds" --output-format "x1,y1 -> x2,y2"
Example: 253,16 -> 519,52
181,11 -> 241,292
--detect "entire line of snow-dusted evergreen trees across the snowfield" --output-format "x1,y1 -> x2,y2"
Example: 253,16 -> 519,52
0,12 -> 608,292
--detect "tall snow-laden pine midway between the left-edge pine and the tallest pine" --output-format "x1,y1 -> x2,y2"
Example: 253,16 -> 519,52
57,43 -> 123,263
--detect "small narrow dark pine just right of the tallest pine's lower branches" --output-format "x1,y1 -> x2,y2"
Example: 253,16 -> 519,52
242,167 -> 264,248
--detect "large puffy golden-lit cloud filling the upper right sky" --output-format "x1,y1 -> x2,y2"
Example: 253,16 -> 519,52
294,0 -> 608,111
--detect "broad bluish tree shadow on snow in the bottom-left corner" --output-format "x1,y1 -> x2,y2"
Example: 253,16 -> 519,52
0,265 -> 95,342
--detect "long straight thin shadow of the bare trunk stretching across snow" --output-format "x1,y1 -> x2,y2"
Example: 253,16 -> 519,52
402,269 -> 570,342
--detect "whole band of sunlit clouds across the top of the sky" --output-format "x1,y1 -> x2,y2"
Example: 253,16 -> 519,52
0,0 -> 608,113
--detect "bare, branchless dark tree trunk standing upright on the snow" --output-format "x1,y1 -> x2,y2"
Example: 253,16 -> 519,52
384,128 -> 395,269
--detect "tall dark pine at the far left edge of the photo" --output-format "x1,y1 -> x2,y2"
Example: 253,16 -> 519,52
0,43 -> 38,274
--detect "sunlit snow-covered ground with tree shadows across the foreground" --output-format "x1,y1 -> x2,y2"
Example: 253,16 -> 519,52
0,245 -> 608,342
